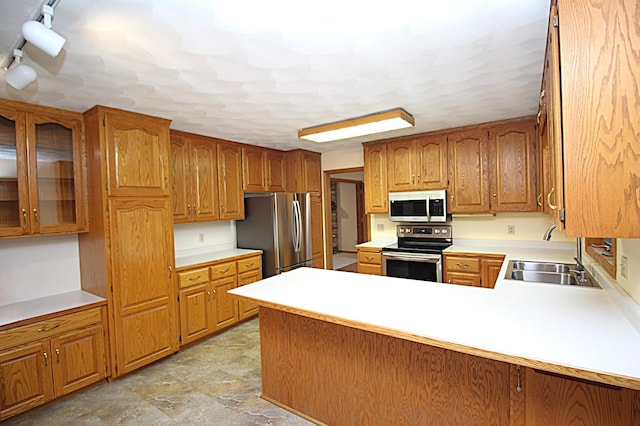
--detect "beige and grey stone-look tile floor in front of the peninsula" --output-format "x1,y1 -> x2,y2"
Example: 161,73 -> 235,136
7,318 -> 312,426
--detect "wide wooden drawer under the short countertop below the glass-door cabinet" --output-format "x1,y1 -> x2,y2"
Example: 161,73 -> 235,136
0,308 -> 102,350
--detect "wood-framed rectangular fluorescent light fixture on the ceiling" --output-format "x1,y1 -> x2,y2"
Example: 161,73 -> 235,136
298,108 -> 415,143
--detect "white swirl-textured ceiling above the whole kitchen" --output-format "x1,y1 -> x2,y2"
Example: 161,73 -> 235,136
0,0 -> 549,152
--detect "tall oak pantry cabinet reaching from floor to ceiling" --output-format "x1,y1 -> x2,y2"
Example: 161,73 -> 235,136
78,106 -> 178,377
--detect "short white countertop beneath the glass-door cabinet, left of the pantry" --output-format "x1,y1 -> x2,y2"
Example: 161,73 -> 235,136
0,290 -> 106,327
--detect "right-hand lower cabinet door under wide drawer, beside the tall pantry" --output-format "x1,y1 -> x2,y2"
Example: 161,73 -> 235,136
51,325 -> 107,397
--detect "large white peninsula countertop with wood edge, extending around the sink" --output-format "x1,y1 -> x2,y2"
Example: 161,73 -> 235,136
230,246 -> 640,389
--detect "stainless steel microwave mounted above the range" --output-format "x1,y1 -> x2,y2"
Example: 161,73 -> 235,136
389,189 -> 447,223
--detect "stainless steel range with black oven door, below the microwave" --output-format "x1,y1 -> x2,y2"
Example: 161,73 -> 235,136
382,224 -> 453,282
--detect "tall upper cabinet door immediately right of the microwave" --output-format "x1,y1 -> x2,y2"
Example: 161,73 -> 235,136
447,128 -> 490,213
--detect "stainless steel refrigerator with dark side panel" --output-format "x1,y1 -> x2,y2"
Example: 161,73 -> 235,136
236,192 -> 312,278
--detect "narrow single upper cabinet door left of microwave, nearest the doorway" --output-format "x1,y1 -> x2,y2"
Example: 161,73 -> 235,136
364,144 -> 389,214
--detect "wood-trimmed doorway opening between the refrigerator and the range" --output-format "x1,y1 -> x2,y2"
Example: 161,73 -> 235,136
324,167 -> 369,272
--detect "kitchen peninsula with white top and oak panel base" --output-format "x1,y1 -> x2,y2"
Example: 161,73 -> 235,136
230,258 -> 640,425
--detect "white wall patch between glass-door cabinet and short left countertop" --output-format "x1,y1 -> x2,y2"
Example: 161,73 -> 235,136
0,234 -> 80,305
